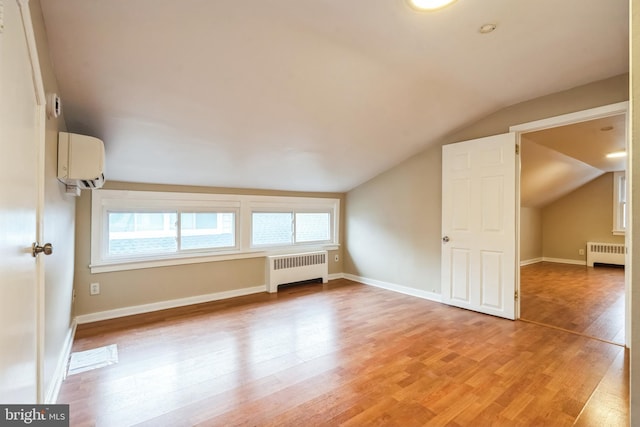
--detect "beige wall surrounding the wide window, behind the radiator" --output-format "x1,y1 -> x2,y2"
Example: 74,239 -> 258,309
75,181 -> 344,315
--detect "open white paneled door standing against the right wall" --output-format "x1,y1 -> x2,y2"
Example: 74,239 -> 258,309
442,133 -> 516,319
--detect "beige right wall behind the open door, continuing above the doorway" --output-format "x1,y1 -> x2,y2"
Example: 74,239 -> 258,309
345,75 -> 629,293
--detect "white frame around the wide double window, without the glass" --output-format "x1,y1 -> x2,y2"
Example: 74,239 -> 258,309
89,189 -> 340,273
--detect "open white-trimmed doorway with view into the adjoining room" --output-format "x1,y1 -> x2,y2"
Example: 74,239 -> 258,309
511,102 -> 631,345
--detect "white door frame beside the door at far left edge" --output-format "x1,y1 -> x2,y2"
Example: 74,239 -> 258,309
17,0 -> 47,403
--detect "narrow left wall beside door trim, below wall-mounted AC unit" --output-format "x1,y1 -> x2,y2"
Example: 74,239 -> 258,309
29,0 -> 75,402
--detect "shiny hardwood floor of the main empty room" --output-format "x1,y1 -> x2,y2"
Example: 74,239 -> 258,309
59,280 -> 628,427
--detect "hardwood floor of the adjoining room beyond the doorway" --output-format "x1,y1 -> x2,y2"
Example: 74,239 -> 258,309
520,262 -> 625,345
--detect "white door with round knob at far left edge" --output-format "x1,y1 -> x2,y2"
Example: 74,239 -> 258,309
0,0 -> 43,404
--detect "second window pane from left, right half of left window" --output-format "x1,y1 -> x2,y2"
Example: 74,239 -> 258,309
180,212 -> 236,249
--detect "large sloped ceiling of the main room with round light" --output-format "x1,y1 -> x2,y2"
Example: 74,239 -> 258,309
42,0 -> 629,191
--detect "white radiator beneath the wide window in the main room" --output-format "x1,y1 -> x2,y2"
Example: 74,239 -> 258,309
266,251 -> 329,293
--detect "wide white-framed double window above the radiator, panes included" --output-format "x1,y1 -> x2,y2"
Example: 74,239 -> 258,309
91,189 -> 340,273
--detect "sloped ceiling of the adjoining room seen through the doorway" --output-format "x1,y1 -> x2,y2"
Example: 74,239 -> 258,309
520,115 -> 626,208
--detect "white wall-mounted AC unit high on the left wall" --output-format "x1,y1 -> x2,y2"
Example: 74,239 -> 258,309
58,132 -> 104,191
